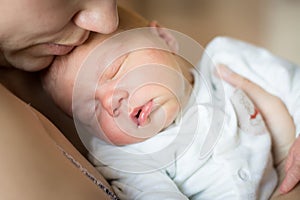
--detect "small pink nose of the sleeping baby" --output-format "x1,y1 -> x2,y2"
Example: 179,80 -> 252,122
96,88 -> 129,117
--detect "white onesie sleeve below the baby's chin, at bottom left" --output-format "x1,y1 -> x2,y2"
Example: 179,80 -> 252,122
89,138 -> 188,200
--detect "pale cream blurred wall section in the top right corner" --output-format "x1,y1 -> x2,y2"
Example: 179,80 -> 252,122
261,0 -> 300,64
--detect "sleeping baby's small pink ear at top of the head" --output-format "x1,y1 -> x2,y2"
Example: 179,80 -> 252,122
149,21 -> 179,53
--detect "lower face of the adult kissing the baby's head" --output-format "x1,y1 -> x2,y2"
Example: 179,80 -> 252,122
0,0 -> 118,71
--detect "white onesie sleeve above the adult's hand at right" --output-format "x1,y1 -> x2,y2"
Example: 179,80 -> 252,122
204,37 -> 300,136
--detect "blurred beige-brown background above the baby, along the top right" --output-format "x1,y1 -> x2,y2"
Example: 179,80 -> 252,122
119,0 -> 300,64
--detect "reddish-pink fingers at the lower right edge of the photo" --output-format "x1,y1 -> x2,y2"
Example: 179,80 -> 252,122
280,137 -> 300,194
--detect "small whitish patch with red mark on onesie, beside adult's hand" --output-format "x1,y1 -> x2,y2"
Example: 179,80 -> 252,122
230,89 -> 267,135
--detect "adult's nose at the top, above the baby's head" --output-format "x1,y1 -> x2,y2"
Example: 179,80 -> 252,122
73,0 -> 119,34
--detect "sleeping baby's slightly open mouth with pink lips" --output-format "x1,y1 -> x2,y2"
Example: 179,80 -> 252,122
130,100 -> 153,126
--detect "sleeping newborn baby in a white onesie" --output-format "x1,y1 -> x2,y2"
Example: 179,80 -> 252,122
43,24 -> 300,200
